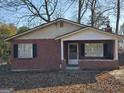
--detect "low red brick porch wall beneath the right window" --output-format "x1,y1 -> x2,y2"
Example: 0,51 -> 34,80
79,60 -> 119,69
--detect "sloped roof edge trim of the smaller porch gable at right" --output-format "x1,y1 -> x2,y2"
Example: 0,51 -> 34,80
55,26 -> 124,40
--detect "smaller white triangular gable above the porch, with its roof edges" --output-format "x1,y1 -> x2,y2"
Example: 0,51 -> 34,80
56,27 -> 124,40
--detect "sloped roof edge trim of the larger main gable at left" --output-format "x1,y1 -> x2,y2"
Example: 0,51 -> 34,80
5,18 -> 86,41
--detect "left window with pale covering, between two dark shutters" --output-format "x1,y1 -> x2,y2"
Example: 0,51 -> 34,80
18,44 -> 33,58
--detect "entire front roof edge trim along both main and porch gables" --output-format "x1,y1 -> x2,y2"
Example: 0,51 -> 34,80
5,18 -> 124,41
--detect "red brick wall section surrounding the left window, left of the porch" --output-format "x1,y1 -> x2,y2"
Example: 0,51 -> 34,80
11,39 -> 61,71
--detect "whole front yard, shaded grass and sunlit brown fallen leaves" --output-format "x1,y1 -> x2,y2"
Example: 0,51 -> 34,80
0,65 -> 124,93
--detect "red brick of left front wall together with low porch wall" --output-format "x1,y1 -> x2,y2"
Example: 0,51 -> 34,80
10,39 -> 118,71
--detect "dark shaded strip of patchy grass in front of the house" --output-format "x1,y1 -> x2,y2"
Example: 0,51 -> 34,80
0,72 -> 97,90
